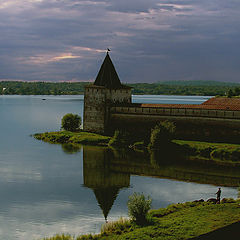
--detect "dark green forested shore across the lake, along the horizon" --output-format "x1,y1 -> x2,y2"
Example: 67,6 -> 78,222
0,81 -> 240,96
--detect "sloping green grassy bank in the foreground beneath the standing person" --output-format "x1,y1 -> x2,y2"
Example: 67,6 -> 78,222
42,200 -> 240,240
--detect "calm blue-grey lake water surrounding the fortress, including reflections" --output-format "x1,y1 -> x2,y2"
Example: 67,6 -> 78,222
0,95 -> 240,240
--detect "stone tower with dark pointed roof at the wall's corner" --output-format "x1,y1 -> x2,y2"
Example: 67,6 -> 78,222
83,52 -> 132,134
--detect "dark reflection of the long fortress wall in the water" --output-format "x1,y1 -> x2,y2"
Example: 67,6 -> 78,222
111,148 -> 240,186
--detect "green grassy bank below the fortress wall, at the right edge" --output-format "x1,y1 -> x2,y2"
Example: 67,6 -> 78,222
174,140 -> 240,163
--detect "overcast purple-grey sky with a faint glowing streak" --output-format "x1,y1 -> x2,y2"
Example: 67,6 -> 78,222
0,0 -> 240,83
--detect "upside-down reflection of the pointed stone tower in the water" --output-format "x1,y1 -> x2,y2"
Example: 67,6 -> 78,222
83,147 -> 130,220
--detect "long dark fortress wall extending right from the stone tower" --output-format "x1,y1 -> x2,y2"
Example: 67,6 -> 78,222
109,107 -> 240,143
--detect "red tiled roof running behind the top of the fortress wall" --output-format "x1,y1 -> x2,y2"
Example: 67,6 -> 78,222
141,98 -> 240,111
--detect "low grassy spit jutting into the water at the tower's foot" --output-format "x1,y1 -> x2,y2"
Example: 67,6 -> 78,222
33,131 -> 111,145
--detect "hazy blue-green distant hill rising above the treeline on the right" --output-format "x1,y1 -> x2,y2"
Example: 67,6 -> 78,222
158,80 -> 240,87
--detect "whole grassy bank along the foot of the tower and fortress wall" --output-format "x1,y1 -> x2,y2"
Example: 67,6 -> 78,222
33,131 -> 240,164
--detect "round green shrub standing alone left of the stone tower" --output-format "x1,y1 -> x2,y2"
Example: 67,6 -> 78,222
62,113 -> 82,132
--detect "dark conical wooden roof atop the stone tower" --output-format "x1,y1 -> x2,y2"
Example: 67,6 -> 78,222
93,53 -> 123,89
